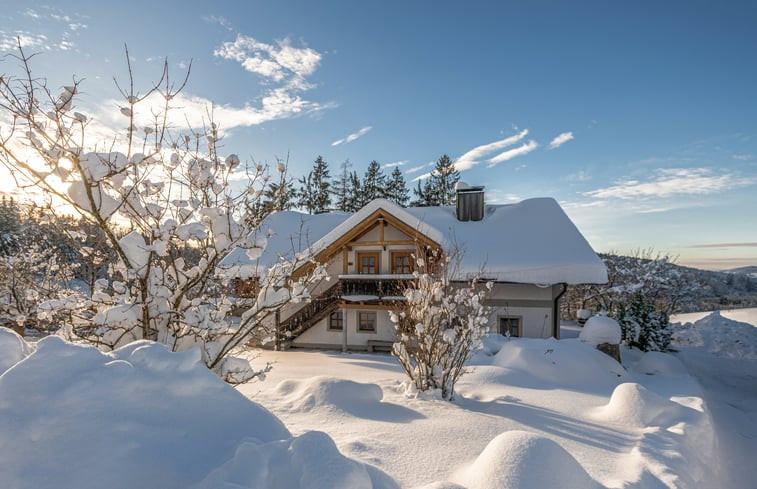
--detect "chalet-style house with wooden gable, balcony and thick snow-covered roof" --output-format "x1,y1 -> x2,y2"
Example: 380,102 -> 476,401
222,185 -> 607,350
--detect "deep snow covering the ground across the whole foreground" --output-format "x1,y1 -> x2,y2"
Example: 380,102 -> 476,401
0,306 -> 757,489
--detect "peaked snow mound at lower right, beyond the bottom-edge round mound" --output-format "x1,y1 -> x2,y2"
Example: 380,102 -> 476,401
590,382 -> 683,428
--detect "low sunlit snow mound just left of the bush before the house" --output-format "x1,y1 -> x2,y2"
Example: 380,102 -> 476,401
276,376 -> 384,413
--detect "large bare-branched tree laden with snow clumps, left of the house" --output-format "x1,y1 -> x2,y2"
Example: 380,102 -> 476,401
0,46 -> 321,380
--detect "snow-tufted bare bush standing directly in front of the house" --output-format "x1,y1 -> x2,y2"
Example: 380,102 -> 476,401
389,250 -> 491,399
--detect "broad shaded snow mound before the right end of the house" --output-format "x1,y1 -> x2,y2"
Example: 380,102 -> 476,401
492,338 -> 628,388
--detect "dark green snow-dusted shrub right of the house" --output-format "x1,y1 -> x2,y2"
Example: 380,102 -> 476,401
612,293 -> 672,351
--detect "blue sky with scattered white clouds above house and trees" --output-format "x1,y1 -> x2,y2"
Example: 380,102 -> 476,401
0,0 -> 757,269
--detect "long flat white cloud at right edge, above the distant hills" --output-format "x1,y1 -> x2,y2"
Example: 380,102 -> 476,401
584,168 -> 757,199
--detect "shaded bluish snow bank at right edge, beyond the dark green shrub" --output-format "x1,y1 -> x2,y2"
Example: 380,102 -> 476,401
672,311 -> 757,360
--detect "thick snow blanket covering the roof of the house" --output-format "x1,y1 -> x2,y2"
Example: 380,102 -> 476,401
222,198 -> 607,284
